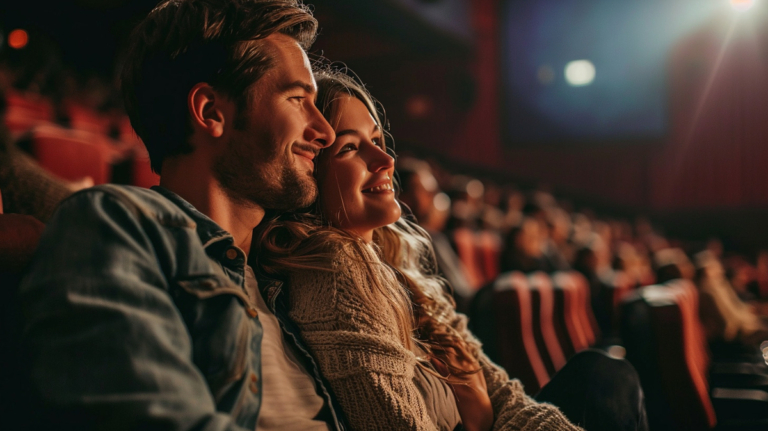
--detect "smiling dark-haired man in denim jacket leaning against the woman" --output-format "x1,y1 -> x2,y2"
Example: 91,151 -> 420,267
20,0 -> 341,430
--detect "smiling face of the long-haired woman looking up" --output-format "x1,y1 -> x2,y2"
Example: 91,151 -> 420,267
317,96 -> 400,241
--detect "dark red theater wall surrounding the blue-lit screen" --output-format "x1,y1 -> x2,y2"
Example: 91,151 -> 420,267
440,0 -> 768,213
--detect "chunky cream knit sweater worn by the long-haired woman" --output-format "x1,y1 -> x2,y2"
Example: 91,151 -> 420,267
286,246 -> 580,431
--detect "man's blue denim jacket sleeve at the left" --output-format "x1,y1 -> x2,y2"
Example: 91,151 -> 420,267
19,190 -> 249,431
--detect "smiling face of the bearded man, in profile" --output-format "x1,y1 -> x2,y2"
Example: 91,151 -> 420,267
213,34 -> 335,210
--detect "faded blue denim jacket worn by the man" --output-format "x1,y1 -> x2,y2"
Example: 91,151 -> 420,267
19,185 -> 343,431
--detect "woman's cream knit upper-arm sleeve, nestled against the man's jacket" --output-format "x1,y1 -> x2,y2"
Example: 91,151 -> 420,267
289,251 -> 437,431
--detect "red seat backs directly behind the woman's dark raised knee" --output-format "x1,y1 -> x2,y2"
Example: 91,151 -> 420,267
469,271 -> 600,395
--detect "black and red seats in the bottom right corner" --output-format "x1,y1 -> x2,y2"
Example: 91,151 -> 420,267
621,280 -> 768,431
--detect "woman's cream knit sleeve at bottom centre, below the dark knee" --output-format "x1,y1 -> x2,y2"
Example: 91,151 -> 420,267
444,301 -> 583,431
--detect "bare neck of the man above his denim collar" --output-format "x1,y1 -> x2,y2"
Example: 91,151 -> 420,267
160,160 -> 264,255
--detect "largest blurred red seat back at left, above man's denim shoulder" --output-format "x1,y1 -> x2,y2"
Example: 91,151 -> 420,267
32,127 -> 111,184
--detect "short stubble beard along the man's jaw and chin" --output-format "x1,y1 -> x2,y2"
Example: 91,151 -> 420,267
213,134 -> 317,211
